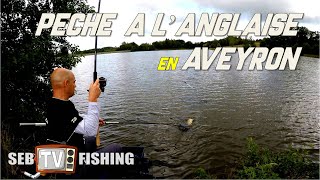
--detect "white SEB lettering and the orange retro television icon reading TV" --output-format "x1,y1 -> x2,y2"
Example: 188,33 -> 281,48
8,144 -> 78,174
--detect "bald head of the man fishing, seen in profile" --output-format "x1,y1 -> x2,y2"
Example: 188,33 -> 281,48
50,68 -> 76,100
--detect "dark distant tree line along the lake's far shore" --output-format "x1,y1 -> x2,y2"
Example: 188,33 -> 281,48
82,27 -> 319,56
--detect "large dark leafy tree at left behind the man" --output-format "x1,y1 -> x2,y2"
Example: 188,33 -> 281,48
1,0 -> 94,178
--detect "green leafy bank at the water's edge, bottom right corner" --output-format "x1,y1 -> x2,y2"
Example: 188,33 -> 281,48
194,138 -> 319,179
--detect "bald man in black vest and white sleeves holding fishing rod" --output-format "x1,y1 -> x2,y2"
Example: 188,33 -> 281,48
47,68 -> 121,178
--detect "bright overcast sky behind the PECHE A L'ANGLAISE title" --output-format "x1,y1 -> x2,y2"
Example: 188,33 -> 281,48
68,0 -> 320,50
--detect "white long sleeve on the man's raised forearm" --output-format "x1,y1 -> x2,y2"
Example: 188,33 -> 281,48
75,102 -> 99,136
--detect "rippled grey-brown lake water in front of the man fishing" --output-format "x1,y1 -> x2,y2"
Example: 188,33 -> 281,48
72,50 -> 320,178
